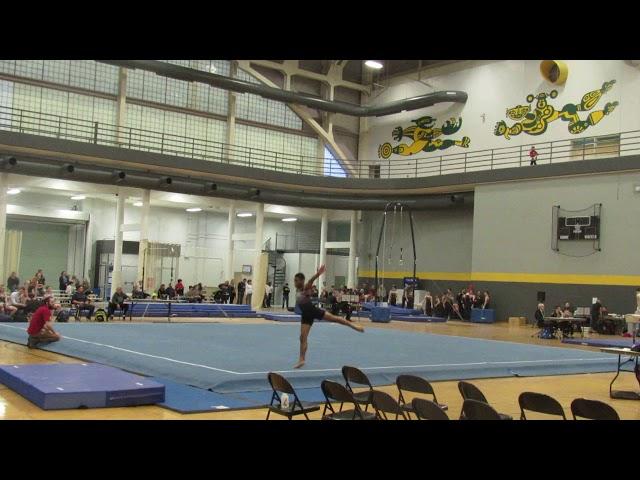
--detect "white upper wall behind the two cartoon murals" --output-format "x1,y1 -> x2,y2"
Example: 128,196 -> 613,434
359,60 -> 640,176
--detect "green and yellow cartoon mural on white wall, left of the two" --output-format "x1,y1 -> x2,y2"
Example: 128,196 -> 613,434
378,115 -> 471,159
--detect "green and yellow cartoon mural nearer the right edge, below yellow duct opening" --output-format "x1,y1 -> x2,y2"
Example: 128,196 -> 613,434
493,80 -> 618,140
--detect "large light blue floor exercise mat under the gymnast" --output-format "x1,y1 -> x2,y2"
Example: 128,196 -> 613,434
0,322 -> 617,393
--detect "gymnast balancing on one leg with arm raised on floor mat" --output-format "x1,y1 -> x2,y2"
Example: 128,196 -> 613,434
293,265 -> 364,368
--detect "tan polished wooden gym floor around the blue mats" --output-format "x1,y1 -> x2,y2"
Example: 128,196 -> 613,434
0,319 -> 640,420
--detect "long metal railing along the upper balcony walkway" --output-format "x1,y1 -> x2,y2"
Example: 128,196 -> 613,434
0,107 -> 640,179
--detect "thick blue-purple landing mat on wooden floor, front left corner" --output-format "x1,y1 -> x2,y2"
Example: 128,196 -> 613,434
0,363 -> 165,410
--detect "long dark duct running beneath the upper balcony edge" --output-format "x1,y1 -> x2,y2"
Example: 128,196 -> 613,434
0,156 -> 473,210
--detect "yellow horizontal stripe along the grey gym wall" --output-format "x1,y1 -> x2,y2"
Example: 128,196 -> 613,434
358,270 -> 640,286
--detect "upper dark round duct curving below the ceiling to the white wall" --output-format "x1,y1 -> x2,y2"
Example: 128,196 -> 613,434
98,60 -> 467,117
